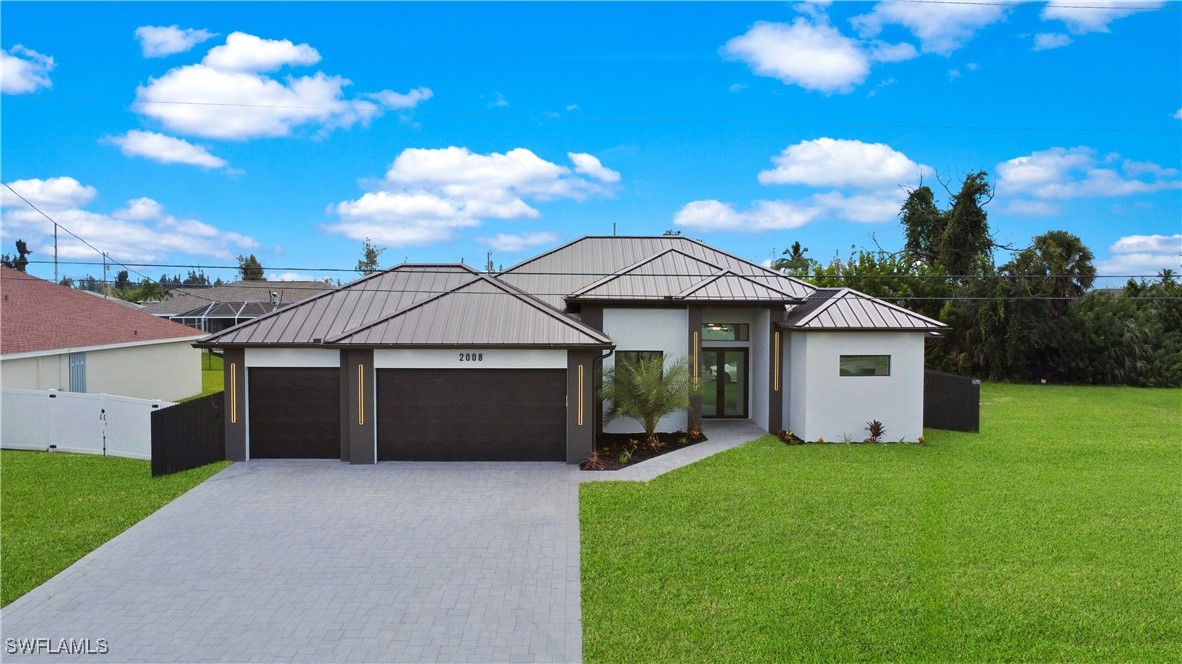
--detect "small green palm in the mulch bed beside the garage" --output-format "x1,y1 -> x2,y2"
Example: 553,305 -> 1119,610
600,354 -> 700,443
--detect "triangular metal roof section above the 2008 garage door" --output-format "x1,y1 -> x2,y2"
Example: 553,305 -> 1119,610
326,274 -> 613,347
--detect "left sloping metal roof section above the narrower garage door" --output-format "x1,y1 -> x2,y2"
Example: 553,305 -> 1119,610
202,263 -> 478,346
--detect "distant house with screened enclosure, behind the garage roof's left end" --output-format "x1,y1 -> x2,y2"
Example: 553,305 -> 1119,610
144,281 -> 336,333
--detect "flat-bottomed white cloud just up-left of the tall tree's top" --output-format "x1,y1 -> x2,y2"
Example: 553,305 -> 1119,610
759,138 -> 931,189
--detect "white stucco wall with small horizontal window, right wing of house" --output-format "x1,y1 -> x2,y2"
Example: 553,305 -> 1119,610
785,332 -> 924,442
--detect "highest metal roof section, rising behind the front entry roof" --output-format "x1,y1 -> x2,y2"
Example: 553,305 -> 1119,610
498,235 -> 816,307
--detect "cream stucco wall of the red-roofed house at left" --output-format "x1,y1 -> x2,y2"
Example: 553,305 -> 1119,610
0,339 -> 201,401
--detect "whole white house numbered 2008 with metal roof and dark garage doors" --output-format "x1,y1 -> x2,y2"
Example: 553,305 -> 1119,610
197,236 -> 946,463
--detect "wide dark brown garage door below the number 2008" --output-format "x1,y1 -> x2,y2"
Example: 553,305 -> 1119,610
377,369 -> 566,461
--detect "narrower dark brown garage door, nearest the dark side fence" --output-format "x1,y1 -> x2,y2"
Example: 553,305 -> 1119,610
249,369 -> 340,458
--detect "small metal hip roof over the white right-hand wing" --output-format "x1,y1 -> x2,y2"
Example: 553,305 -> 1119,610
781,288 -> 948,332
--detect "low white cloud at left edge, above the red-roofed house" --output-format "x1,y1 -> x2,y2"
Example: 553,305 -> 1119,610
2,183 -> 259,261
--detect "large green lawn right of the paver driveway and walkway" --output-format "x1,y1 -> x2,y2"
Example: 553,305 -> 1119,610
580,384 -> 1182,662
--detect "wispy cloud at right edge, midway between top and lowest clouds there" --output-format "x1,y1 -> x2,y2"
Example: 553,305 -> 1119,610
998,147 -> 1182,198
